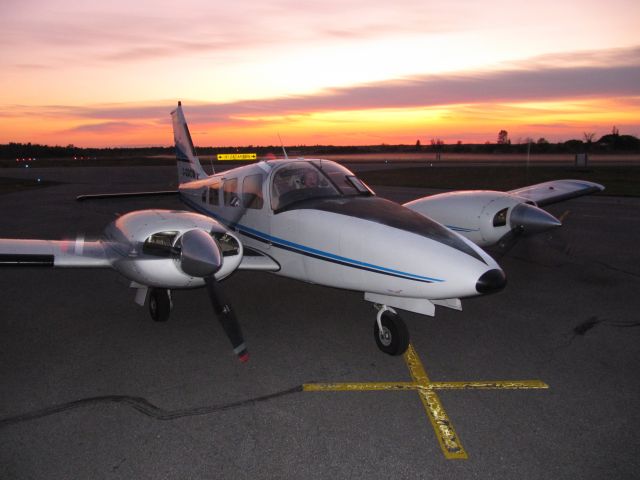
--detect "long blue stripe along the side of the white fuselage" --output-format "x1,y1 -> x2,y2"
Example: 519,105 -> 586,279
180,195 -> 444,283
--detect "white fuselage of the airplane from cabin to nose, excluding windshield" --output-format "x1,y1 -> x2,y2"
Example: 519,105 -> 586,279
180,160 -> 499,300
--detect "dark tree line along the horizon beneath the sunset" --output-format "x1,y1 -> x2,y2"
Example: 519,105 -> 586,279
0,127 -> 640,160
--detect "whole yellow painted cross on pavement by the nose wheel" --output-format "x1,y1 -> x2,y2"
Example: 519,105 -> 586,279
303,344 -> 549,460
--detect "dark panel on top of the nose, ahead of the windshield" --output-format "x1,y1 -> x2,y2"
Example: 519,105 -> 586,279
282,197 -> 487,264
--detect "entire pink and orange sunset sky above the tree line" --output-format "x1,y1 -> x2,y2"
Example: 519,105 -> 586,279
0,0 -> 640,147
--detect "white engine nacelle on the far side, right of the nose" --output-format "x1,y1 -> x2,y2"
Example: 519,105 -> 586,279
404,190 -> 532,247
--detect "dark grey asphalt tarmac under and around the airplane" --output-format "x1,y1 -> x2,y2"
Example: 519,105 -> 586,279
0,167 -> 640,479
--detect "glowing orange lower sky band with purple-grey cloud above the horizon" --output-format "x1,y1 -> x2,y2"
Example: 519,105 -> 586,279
0,47 -> 640,146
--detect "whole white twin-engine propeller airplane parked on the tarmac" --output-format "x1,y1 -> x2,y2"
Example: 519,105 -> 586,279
0,103 -> 603,361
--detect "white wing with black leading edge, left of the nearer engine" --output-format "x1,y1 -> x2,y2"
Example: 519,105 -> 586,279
0,238 -> 111,268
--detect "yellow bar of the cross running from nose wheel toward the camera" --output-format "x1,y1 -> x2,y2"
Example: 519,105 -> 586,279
404,344 -> 468,460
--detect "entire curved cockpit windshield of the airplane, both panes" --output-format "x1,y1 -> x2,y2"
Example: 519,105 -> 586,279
271,160 -> 373,211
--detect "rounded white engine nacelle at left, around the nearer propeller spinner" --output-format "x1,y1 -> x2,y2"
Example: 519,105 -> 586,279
105,210 -> 243,289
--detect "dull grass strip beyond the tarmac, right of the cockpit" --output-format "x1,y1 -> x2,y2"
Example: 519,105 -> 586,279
359,165 -> 640,197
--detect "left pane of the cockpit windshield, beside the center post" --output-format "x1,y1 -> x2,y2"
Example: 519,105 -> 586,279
271,162 -> 340,210
